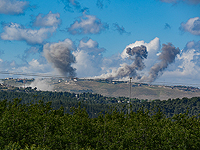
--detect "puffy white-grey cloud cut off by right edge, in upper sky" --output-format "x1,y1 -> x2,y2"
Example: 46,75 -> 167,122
180,17 -> 200,35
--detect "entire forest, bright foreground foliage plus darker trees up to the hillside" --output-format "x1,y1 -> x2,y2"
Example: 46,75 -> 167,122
0,88 -> 200,150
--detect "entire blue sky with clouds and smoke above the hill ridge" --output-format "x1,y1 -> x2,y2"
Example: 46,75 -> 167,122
0,0 -> 200,87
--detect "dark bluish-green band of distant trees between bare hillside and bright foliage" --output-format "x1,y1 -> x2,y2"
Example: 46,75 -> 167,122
0,88 -> 200,118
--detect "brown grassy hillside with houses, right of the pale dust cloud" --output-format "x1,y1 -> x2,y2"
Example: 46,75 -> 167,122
54,80 -> 200,100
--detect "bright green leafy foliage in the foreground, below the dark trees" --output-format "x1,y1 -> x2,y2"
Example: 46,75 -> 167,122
0,99 -> 200,150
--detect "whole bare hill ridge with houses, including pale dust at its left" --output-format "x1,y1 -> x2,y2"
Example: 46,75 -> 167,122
2,78 -> 200,100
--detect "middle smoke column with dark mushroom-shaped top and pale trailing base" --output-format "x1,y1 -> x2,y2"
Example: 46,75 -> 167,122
97,45 -> 148,80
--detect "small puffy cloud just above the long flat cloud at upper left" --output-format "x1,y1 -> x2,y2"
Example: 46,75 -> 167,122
33,11 -> 61,27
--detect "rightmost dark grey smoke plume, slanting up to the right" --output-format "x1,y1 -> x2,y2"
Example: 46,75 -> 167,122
147,43 -> 180,82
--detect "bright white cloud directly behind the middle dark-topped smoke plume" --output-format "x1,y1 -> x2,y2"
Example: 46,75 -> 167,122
96,37 -> 160,78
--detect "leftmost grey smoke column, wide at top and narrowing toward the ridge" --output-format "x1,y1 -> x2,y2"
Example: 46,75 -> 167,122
43,39 -> 76,76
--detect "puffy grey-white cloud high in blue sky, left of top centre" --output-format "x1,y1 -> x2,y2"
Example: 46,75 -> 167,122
68,13 -> 108,35
